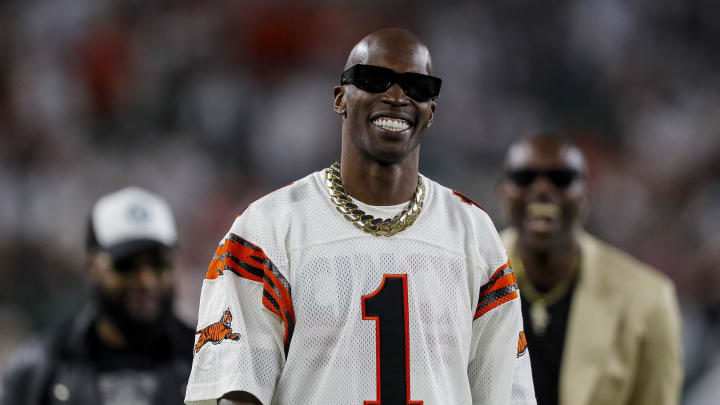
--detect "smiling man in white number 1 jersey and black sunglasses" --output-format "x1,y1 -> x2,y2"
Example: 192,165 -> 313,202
186,29 -> 535,405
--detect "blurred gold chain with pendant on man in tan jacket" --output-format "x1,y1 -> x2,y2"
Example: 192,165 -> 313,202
510,257 -> 580,336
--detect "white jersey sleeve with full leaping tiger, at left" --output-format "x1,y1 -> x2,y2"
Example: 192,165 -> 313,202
185,211 -> 295,405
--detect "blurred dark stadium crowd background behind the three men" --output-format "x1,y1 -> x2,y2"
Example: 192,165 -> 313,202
0,0 -> 720,400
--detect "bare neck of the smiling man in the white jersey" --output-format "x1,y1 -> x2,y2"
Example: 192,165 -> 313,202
340,144 -> 419,205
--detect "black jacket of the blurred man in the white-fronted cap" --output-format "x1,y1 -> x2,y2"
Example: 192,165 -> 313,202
0,306 -> 194,405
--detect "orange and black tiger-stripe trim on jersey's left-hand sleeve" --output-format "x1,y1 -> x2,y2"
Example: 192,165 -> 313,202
205,233 -> 295,355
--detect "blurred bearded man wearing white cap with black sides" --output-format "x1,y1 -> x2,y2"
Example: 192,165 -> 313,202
0,187 -> 193,405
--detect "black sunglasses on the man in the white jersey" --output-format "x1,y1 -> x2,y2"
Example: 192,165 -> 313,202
340,64 -> 442,103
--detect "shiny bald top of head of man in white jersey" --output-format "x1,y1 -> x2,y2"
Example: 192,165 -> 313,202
345,28 -> 432,75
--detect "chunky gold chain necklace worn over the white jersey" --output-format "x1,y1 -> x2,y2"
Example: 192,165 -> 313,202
325,162 -> 425,236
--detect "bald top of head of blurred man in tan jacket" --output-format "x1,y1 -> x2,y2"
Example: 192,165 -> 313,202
505,132 -> 587,175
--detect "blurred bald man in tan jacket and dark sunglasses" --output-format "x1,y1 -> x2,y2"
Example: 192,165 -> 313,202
498,134 -> 683,405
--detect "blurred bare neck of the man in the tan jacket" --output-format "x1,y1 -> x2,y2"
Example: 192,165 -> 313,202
516,237 -> 580,291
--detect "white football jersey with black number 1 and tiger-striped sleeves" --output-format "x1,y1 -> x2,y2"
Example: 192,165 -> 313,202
185,171 -> 535,405
